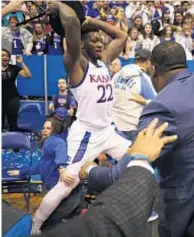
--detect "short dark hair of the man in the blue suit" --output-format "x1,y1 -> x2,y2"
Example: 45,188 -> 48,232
151,41 -> 187,74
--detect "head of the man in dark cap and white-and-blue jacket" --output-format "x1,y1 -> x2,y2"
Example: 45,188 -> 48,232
135,49 -> 153,76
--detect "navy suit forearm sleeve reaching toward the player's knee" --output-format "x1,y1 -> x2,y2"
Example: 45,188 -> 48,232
88,157 -> 129,192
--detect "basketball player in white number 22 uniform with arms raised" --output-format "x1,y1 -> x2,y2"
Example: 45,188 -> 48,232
33,2 -> 131,233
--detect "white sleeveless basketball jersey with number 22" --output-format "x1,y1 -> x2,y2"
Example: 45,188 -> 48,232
70,60 -> 113,129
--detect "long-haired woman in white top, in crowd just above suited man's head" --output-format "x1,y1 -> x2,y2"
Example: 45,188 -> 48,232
141,23 -> 160,51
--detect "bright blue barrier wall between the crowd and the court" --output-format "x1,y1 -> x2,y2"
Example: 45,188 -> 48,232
17,55 -> 194,96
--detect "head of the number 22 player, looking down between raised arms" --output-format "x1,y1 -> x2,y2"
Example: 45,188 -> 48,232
81,28 -> 104,60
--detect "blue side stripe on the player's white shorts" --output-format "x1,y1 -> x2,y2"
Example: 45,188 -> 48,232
73,132 -> 91,163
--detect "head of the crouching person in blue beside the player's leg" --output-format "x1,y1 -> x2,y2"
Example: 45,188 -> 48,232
41,118 -> 63,142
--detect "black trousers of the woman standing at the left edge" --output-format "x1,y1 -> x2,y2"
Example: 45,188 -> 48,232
2,97 -> 20,131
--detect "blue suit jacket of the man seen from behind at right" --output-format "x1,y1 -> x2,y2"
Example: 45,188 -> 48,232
138,70 -> 194,237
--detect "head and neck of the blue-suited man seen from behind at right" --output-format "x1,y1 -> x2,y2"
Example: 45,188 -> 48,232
151,41 -> 187,92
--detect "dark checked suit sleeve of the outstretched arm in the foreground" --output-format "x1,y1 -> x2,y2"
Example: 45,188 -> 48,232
41,166 -> 157,237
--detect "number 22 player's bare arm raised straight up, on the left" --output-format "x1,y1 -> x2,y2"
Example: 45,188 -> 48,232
51,2 -> 87,85
